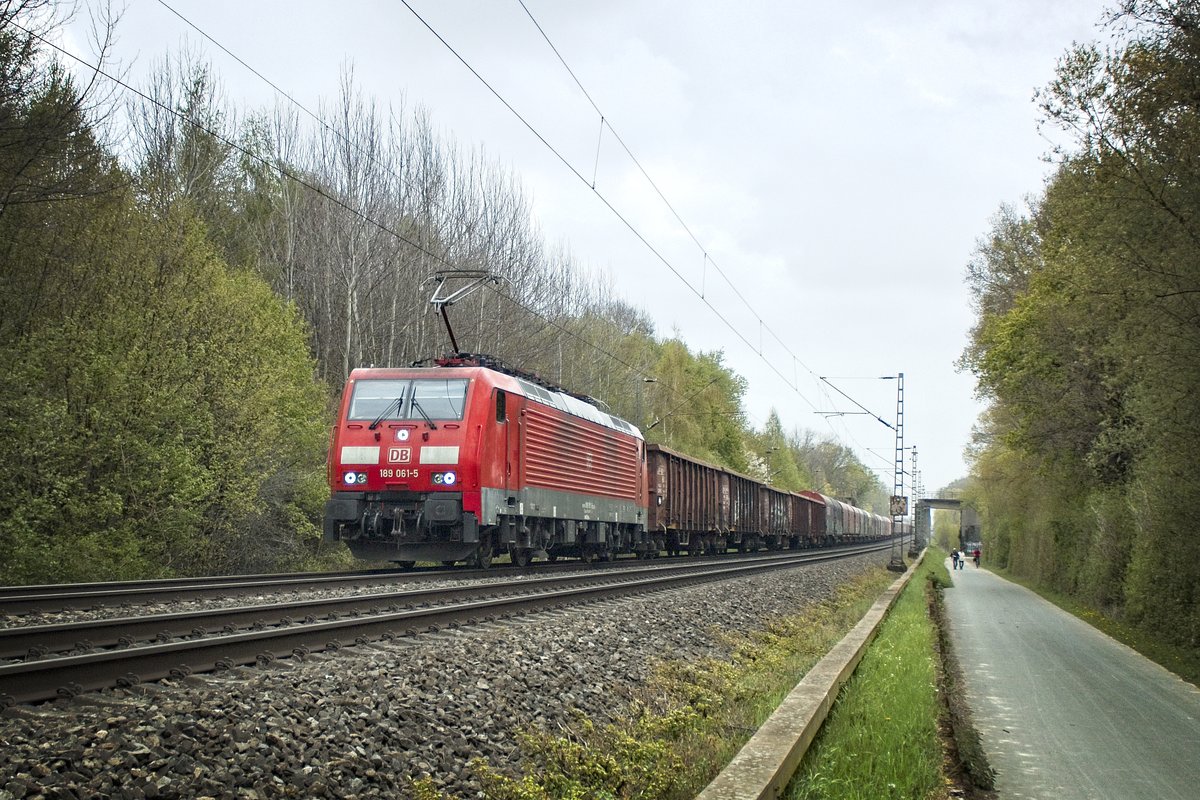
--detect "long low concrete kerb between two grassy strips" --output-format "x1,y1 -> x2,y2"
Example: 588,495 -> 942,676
696,552 -> 925,800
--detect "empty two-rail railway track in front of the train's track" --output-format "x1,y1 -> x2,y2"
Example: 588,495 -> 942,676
0,542 -> 890,706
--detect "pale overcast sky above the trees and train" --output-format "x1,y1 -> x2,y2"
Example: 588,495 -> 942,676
63,0 -> 1110,489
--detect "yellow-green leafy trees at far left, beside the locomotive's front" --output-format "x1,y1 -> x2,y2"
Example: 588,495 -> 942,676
0,3 -> 326,583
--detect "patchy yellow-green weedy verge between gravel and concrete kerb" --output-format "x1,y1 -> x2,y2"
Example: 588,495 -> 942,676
441,567 -> 895,800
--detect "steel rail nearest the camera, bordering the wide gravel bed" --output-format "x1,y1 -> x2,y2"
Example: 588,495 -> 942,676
0,543 -> 887,706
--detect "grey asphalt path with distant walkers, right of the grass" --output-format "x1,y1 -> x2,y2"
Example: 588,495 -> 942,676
946,560 -> 1200,800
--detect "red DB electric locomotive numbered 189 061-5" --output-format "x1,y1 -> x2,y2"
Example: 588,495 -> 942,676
324,355 -> 656,566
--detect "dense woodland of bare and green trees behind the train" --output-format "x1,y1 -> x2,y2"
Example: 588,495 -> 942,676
0,0 -> 886,583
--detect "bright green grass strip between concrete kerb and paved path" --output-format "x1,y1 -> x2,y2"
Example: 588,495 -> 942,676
785,551 -> 949,800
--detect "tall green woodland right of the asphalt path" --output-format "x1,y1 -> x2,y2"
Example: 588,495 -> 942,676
962,0 -> 1200,646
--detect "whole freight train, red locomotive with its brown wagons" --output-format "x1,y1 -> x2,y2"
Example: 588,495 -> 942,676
324,354 -> 892,567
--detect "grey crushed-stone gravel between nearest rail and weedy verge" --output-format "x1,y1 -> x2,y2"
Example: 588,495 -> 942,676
0,552 -> 888,800
